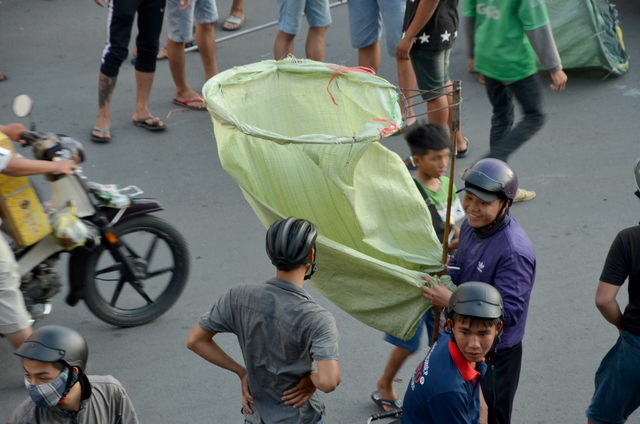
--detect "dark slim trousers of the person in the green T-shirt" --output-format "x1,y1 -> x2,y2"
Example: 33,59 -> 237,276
484,75 -> 544,162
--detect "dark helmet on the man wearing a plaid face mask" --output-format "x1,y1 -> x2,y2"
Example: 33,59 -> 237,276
15,325 -> 89,376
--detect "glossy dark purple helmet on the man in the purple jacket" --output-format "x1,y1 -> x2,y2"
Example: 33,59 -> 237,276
457,158 -> 518,202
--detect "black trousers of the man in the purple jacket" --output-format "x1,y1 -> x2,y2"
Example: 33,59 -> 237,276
480,342 -> 522,424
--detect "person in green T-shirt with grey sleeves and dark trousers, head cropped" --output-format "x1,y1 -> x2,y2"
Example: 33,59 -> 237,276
463,0 -> 567,202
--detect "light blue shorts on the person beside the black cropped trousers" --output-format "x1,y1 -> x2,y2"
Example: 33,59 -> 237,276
166,0 -> 218,43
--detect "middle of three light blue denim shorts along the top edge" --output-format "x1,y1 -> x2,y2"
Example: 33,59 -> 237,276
278,0 -> 331,35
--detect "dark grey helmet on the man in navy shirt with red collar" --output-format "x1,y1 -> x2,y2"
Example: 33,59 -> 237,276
447,281 -> 504,318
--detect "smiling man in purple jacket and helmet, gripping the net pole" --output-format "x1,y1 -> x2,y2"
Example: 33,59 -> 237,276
422,159 -> 536,424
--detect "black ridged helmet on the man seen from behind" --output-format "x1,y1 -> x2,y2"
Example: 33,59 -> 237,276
266,217 -> 318,279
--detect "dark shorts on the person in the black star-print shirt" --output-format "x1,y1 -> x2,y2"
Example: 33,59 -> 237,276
409,49 -> 451,100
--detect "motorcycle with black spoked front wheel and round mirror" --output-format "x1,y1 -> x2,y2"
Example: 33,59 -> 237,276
5,95 -> 190,327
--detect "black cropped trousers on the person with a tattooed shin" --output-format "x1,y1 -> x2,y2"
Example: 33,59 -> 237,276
100,0 -> 166,78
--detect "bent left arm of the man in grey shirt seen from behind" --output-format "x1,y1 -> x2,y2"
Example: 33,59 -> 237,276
187,324 -> 253,414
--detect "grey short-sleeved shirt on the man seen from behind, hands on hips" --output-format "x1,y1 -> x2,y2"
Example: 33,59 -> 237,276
200,278 -> 338,424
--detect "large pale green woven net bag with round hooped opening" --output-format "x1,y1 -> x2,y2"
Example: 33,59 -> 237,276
203,58 -> 453,339
